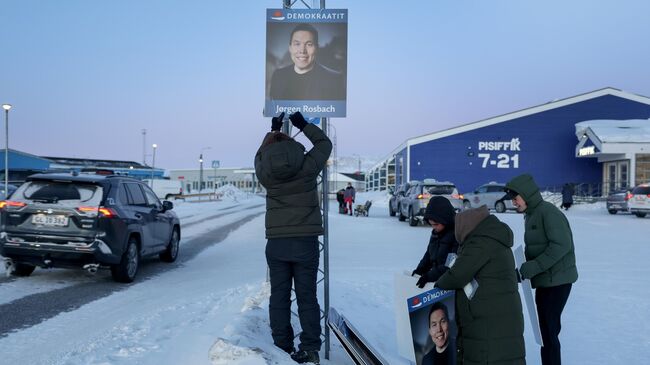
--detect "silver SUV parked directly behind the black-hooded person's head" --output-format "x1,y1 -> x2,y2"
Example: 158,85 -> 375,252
398,179 -> 463,226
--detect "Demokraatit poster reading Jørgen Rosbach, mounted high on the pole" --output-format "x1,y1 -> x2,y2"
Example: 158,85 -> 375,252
264,9 -> 348,118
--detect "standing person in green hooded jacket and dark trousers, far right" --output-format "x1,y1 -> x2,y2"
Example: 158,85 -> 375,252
505,174 -> 578,365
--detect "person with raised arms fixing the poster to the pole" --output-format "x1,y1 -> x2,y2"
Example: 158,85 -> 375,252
255,112 -> 332,364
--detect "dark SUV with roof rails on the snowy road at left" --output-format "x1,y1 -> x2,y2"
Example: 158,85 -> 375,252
0,174 -> 181,283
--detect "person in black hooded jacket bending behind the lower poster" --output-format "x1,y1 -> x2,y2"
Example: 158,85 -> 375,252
411,196 -> 458,288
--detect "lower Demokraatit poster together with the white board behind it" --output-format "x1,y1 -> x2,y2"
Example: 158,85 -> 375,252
395,275 -> 458,365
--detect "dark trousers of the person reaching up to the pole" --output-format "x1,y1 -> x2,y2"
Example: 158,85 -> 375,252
266,236 -> 321,352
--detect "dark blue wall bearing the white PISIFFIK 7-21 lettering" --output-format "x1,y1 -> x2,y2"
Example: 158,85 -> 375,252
410,95 -> 650,192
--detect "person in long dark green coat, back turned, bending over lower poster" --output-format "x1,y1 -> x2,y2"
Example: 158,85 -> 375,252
435,205 -> 526,365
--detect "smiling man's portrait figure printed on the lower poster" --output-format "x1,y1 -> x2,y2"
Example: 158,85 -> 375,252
421,302 -> 456,365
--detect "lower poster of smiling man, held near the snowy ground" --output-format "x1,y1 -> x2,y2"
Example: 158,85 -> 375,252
407,288 -> 457,365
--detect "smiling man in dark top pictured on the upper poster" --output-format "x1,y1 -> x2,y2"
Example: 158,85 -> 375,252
270,23 -> 345,100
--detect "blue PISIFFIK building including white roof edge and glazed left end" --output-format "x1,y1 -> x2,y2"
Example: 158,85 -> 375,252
366,88 -> 650,192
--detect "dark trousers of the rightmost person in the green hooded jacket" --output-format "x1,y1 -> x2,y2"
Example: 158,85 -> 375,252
535,284 -> 571,365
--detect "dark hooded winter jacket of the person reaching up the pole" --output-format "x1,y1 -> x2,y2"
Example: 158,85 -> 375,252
255,124 -> 332,238
